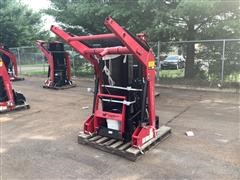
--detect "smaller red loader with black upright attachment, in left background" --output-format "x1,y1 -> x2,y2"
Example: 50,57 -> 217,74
36,40 -> 76,89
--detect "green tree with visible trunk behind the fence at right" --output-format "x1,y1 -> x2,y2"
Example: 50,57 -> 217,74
154,0 -> 240,78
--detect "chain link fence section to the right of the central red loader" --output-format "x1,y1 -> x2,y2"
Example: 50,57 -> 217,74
150,39 -> 240,88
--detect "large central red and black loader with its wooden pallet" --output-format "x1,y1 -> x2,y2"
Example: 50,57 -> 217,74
51,17 -> 171,161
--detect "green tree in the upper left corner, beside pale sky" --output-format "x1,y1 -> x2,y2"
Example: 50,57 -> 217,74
0,0 -> 49,47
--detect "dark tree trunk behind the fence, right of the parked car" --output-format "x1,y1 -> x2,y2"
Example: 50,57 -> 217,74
185,23 -> 195,79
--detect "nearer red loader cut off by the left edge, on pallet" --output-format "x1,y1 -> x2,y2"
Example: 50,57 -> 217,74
0,58 -> 30,113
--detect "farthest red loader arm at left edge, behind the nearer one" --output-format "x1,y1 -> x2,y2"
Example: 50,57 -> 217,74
0,45 -> 24,81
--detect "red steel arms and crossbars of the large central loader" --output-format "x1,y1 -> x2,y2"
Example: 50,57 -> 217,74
51,17 -> 156,148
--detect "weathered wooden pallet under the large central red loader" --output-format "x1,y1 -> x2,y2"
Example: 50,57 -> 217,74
78,126 -> 171,161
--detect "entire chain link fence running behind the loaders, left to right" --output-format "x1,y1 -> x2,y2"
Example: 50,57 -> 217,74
10,39 -> 240,88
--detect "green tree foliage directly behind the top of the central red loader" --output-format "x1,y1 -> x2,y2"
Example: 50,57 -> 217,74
47,0 -> 162,34
